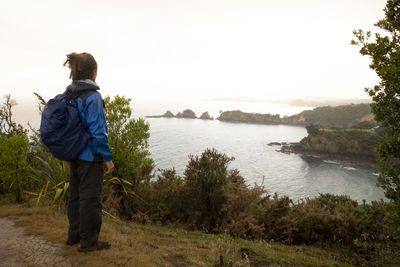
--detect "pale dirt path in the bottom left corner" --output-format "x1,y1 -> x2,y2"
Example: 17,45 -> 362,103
0,218 -> 72,267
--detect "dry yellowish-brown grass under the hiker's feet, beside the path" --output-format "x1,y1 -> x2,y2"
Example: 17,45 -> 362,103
0,205 -> 356,266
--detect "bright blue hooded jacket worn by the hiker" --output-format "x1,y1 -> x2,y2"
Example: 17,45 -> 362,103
66,79 -> 112,162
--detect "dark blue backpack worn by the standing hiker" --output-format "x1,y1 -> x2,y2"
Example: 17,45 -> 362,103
40,90 -> 96,161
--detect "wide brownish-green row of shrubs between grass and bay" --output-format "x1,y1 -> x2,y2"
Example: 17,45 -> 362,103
142,149 -> 399,262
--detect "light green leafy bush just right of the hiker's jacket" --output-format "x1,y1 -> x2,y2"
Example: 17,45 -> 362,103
104,95 -> 154,219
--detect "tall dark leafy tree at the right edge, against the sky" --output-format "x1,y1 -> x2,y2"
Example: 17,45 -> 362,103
352,0 -> 400,228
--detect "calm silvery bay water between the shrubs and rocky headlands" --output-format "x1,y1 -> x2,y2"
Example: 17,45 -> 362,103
148,118 -> 384,201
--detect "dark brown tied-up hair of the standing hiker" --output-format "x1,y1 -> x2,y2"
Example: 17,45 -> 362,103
63,52 -> 97,81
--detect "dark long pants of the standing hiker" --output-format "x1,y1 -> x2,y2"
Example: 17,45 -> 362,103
67,159 -> 104,247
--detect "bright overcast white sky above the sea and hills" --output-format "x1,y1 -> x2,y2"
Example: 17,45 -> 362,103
0,0 -> 386,101
